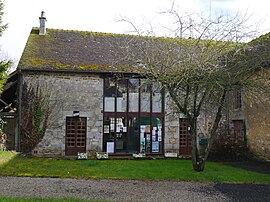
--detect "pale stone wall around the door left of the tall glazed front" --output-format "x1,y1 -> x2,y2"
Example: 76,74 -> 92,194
24,73 -> 103,156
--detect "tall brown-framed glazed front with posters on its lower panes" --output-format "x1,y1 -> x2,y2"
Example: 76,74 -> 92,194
103,78 -> 164,153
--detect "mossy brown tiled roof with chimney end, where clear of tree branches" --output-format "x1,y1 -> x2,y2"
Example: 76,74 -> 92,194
18,28 -> 269,72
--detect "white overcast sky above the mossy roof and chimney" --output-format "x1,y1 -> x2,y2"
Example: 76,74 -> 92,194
0,0 -> 270,68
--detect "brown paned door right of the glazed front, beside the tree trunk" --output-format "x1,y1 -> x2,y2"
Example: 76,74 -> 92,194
179,119 -> 192,155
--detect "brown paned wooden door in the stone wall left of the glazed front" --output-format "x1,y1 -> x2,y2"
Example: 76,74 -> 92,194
66,117 -> 86,156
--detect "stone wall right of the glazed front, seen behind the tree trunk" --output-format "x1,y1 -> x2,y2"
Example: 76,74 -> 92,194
164,93 -> 244,155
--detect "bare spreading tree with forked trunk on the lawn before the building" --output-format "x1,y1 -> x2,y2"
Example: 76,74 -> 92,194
118,7 -> 269,171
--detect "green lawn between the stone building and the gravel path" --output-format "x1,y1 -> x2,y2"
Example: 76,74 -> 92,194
0,152 -> 270,184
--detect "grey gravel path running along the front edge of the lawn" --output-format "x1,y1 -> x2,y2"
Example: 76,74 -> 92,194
0,176 -> 270,202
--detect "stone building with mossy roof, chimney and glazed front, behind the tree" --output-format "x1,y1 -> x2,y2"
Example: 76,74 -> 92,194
3,13 -> 260,159
